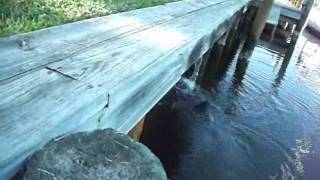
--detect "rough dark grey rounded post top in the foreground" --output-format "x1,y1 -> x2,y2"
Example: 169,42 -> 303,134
23,129 -> 166,180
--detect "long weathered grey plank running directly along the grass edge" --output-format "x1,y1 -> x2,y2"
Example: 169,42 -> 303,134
0,0 -> 228,81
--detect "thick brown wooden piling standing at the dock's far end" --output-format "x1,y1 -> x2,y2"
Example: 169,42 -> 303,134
250,0 -> 274,40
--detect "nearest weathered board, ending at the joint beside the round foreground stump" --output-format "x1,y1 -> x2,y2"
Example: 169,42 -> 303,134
0,69 -> 108,179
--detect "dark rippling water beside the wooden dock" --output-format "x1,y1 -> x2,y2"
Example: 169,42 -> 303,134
141,32 -> 320,180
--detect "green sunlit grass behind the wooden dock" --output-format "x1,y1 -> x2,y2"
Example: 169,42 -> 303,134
0,0 -> 176,36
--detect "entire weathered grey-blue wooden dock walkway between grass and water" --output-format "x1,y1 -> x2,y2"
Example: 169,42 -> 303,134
0,0 -> 251,179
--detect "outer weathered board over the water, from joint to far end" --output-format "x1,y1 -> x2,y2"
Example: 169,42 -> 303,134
49,1 -> 245,132
